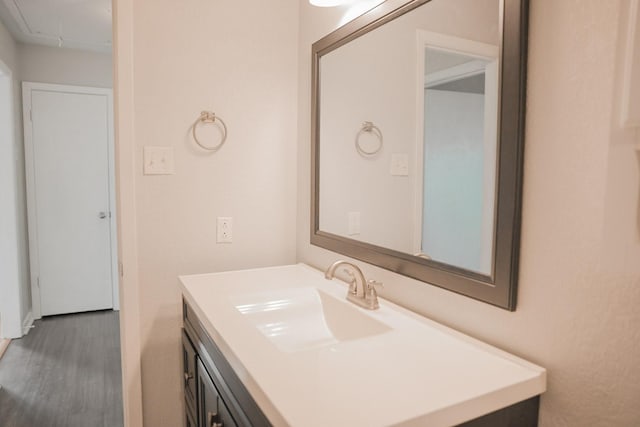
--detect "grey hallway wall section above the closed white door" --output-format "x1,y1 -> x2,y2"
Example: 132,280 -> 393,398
18,44 -> 113,88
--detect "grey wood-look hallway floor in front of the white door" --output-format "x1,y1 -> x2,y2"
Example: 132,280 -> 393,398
0,311 -> 123,427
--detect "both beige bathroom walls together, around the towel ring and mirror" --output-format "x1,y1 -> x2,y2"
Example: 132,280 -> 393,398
115,0 -> 640,426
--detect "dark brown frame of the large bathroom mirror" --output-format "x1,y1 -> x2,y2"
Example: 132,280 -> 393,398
311,0 -> 528,311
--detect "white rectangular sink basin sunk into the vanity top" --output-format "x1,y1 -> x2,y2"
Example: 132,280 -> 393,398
231,287 -> 391,352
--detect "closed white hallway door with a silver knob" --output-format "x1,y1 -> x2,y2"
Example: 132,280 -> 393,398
24,83 -> 113,316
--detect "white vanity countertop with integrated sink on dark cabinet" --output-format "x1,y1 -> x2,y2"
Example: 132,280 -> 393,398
180,264 -> 546,427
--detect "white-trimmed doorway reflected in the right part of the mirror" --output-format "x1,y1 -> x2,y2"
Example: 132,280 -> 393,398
415,35 -> 499,275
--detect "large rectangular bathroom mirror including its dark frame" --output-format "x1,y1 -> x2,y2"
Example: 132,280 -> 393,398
311,0 -> 528,310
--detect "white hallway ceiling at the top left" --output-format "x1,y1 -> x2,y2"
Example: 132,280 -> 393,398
0,0 -> 112,52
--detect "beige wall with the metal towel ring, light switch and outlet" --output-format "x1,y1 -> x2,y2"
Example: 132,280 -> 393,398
115,0 -> 298,426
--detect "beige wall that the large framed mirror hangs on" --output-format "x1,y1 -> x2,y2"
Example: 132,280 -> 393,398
298,0 -> 640,426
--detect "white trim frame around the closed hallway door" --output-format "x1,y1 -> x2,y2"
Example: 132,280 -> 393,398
22,82 -> 120,319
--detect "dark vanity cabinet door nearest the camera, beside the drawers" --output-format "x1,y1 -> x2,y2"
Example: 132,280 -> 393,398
197,359 -> 236,427
